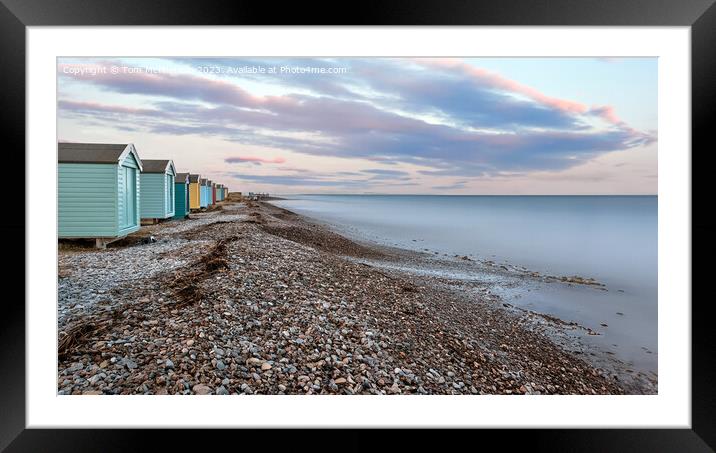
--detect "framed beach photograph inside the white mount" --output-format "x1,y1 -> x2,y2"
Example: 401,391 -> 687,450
57,55 -> 659,399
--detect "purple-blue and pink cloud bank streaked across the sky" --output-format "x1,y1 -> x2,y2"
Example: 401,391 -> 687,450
58,59 -> 656,188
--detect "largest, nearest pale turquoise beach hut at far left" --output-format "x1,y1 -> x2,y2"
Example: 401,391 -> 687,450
57,143 -> 143,248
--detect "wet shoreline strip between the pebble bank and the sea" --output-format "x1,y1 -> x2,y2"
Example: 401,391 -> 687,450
268,198 -> 658,394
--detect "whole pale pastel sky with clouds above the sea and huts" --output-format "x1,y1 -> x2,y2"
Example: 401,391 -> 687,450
57,57 -> 658,195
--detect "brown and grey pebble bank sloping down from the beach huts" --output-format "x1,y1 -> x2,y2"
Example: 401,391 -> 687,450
58,201 -> 641,394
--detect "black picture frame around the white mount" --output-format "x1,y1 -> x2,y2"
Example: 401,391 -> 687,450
0,0 -> 716,452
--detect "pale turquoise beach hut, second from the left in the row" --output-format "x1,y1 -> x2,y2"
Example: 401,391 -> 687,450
139,159 -> 177,221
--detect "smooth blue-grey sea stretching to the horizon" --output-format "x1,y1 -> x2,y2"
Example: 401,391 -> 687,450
274,195 -> 657,372
